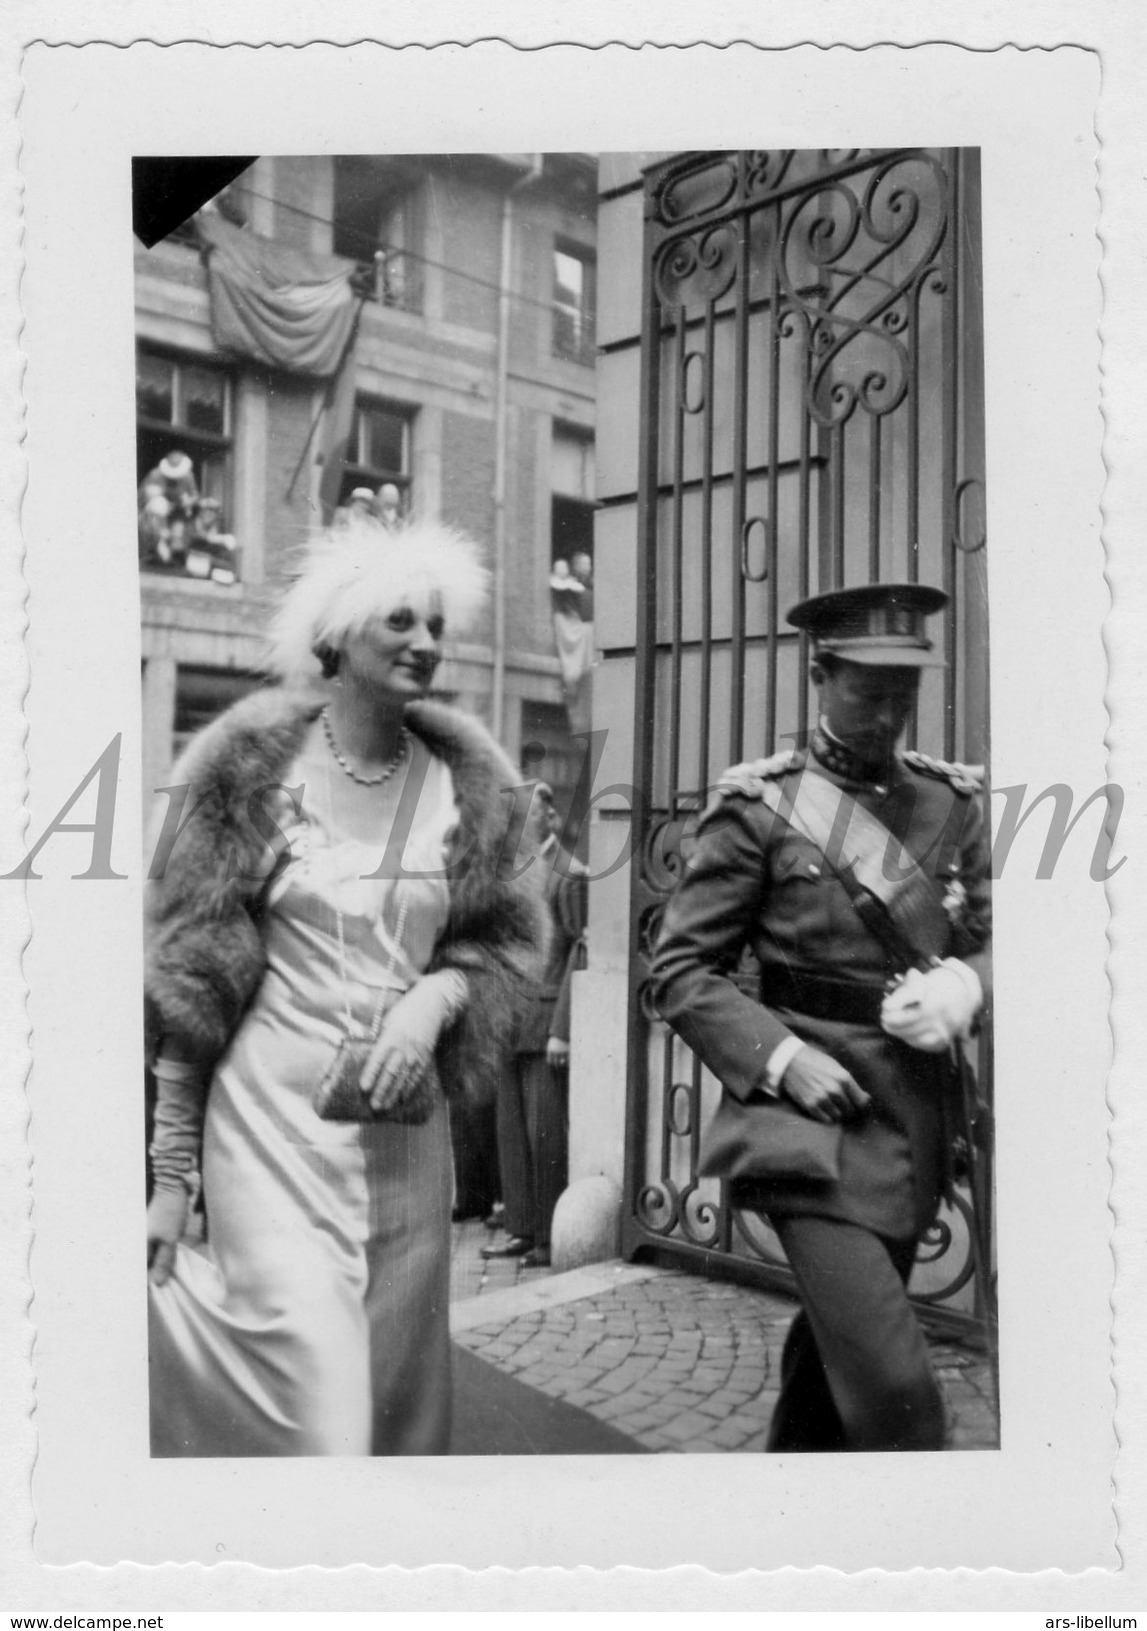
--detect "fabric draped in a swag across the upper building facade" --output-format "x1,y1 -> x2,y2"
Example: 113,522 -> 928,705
197,210 -> 356,380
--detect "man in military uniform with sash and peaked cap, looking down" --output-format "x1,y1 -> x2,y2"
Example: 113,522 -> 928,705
653,584 -> 989,1450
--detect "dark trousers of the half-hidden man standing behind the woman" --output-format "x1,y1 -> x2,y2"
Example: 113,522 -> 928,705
498,1054 -> 569,1246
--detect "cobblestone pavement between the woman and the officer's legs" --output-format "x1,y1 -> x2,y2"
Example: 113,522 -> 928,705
455,1236 -> 997,1453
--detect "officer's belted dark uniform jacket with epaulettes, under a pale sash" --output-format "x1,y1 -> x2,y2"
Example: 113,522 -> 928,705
653,752 -> 990,1238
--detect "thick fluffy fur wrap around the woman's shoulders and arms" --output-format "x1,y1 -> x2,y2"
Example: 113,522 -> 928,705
145,687 -> 548,1101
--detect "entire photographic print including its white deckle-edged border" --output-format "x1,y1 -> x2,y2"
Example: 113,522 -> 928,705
0,25 -> 1136,1611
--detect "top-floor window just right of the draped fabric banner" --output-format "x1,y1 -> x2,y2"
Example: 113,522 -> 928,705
333,157 -> 423,312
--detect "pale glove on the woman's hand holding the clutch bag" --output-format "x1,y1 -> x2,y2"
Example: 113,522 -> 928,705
362,969 -> 470,1122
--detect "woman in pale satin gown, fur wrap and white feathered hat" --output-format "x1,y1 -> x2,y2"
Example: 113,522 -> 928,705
148,524 -> 542,1456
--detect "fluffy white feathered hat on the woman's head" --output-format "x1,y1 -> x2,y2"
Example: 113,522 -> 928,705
269,515 -> 489,682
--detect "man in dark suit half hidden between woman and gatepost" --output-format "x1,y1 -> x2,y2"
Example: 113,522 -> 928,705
481,781 -> 586,1269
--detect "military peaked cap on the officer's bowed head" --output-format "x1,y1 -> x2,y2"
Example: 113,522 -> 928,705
788,584 -> 948,669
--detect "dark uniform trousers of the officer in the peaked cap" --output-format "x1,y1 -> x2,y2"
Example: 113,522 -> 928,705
768,1217 -> 945,1452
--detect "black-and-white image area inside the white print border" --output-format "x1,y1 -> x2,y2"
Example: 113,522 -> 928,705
132,147 -> 999,1456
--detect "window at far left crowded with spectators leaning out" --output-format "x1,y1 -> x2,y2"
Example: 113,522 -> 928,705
135,347 -> 238,582
